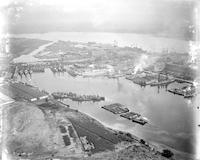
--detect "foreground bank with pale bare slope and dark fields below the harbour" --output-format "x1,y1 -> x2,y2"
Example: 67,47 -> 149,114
0,86 -> 171,160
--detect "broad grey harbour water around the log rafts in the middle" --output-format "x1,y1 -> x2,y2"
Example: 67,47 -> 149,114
19,69 -> 194,153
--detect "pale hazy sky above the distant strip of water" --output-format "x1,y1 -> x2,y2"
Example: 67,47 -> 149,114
3,0 -> 195,38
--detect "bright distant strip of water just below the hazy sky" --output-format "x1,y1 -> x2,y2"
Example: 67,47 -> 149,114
11,32 -> 189,53
